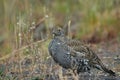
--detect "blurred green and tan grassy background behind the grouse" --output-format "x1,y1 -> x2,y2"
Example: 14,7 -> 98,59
0,0 -> 120,79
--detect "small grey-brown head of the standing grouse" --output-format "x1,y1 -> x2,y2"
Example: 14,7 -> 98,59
52,27 -> 65,37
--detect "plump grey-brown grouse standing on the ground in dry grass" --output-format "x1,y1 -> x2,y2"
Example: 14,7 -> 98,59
48,28 -> 115,76
